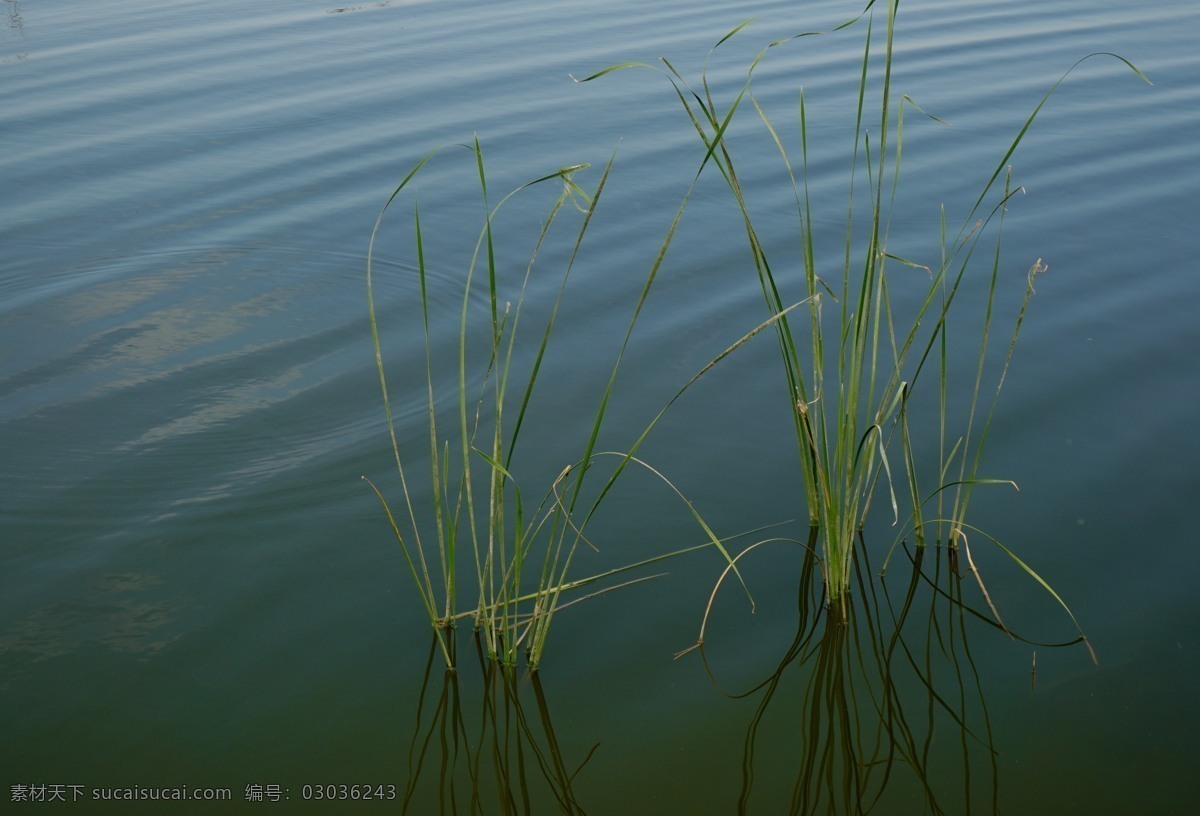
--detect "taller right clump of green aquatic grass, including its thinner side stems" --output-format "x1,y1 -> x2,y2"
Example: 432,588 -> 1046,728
580,0 -> 1148,628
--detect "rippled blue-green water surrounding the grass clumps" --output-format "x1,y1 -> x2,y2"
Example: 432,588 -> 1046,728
0,0 -> 1200,814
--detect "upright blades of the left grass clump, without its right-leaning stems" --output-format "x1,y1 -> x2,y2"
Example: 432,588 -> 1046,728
367,138 -> 628,666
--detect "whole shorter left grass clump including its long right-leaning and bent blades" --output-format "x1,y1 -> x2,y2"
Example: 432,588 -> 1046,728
367,139 -> 772,668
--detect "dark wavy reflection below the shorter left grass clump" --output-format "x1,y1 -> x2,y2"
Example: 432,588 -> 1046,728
403,638 -> 595,815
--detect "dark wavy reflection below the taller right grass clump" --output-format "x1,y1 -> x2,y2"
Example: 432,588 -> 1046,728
700,536 -> 1056,815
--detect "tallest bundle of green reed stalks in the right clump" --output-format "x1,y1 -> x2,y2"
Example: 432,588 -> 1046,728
588,6 -> 899,612
